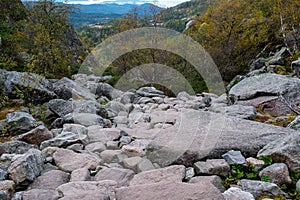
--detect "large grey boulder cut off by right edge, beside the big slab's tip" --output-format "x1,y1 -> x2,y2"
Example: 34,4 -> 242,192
257,132 -> 300,172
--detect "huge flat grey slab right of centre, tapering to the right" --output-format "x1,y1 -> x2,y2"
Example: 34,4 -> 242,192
147,110 -> 293,166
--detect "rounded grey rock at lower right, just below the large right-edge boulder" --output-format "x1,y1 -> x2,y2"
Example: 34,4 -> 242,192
259,163 -> 292,186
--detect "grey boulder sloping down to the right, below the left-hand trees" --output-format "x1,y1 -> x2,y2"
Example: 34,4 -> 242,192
53,78 -> 95,101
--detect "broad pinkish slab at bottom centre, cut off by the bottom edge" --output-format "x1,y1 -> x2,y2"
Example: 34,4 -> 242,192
116,182 -> 224,200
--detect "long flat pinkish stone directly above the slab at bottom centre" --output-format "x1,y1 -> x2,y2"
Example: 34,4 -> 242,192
130,165 -> 185,186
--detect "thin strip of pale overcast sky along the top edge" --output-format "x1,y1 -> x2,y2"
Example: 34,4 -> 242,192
68,0 -> 188,7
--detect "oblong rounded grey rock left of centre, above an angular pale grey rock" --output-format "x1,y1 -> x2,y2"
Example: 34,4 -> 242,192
63,113 -> 104,128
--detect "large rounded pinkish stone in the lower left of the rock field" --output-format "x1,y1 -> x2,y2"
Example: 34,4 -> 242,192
53,149 -> 99,172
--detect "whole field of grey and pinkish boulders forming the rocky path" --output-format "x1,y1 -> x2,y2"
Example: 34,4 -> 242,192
0,70 -> 300,200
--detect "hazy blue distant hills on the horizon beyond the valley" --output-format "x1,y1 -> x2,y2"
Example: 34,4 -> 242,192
70,3 -> 163,28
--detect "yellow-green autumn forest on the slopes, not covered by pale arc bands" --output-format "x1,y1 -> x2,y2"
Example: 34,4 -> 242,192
0,0 -> 300,92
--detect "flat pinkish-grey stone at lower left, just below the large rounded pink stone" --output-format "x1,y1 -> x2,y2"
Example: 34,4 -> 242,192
28,170 -> 70,190
